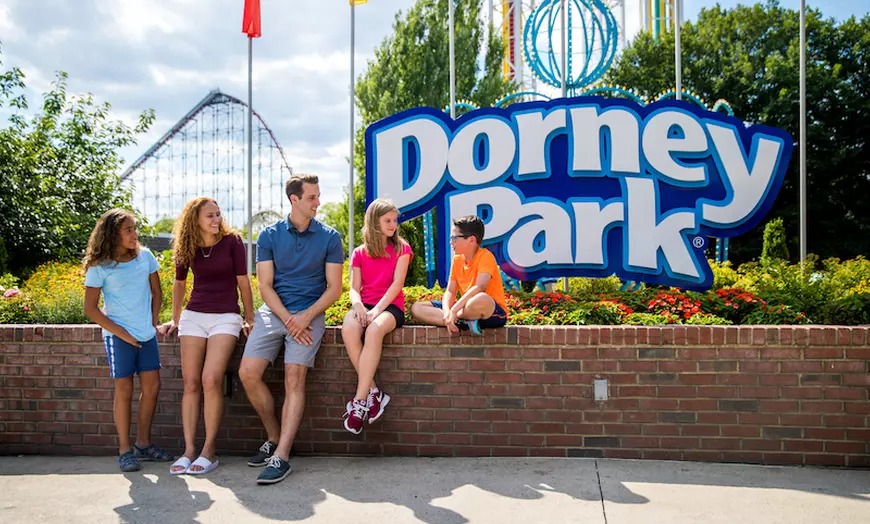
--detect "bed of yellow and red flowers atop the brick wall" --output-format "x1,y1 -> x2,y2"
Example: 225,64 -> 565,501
0,252 -> 870,325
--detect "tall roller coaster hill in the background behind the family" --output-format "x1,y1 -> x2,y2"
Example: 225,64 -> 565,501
121,90 -> 292,231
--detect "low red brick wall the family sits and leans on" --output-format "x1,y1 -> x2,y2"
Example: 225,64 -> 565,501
0,326 -> 870,467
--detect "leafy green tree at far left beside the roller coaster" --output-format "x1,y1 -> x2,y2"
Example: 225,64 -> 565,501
0,53 -> 154,273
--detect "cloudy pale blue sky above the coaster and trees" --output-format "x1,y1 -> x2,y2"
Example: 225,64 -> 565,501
0,0 -> 870,209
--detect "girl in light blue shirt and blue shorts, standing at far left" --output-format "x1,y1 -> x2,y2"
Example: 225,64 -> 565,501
83,209 -> 173,472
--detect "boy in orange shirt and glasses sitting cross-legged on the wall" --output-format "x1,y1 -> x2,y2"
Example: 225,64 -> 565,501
411,215 -> 507,335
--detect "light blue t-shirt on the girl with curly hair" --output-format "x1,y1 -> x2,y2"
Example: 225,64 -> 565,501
85,247 -> 160,342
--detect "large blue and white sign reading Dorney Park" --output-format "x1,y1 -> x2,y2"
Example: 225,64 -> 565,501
365,97 -> 793,290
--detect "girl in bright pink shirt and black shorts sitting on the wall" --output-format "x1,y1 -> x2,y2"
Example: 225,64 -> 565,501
341,199 -> 413,435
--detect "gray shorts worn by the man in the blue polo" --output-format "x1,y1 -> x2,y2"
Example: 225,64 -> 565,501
242,304 -> 326,368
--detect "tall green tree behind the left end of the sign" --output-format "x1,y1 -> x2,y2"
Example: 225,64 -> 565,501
324,0 -> 515,285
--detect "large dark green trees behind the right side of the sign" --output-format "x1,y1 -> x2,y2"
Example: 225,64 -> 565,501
605,0 -> 870,261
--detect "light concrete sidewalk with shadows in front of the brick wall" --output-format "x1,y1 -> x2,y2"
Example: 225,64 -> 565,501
0,456 -> 870,524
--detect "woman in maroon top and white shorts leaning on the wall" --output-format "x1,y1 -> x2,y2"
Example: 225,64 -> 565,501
158,197 -> 254,475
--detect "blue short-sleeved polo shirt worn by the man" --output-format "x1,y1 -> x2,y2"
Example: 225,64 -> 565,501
257,217 -> 344,313
